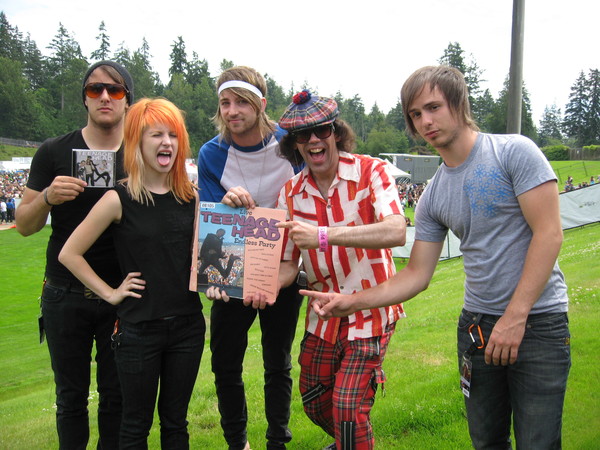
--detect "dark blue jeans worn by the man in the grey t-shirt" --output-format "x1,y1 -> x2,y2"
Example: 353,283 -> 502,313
458,310 -> 571,450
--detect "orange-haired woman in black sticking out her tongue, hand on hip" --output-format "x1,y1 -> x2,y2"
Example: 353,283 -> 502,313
59,98 -> 205,449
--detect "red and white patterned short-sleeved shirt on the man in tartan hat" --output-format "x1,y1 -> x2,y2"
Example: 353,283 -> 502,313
278,152 -> 404,343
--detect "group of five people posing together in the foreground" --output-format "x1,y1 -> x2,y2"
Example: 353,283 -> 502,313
10,61 -> 571,450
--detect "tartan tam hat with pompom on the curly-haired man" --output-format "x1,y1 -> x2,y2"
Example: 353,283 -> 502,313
279,89 -> 339,132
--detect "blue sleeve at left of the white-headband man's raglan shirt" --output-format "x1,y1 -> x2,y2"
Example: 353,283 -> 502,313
198,136 -> 229,202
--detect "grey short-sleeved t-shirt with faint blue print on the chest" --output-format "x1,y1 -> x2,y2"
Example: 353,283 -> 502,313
415,133 -> 568,315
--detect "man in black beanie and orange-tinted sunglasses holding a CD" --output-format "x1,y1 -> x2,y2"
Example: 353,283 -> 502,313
16,61 -> 134,449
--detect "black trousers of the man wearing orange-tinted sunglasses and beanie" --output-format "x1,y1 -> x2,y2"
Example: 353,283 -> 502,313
42,283 -> 121,450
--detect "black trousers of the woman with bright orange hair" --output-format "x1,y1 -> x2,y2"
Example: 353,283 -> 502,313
115,314 -> 206,450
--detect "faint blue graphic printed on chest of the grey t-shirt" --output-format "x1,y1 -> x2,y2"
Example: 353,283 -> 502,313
463,164 -> 511,218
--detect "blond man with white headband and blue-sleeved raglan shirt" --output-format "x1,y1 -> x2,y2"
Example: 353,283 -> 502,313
198,66 -> 302,450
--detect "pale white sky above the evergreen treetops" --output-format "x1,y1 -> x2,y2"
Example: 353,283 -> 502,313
0,0 -> 600,125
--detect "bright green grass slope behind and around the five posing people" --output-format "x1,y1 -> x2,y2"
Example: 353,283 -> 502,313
0,224 -> 600,450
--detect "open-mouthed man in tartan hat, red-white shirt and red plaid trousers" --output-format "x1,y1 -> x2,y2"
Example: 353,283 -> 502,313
270,90 -> 406,449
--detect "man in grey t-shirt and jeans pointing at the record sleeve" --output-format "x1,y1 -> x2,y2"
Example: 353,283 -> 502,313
308,66 -> 571,448
